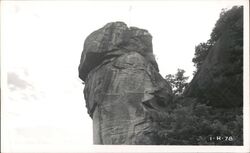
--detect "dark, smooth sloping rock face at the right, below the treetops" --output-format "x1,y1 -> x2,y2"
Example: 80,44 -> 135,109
184,10 -> 243,108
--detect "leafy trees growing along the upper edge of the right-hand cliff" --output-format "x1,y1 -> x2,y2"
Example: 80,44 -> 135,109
192,6 -> 243,74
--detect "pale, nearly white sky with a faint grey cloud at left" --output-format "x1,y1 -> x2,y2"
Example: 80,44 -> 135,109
1,0 -> 246,151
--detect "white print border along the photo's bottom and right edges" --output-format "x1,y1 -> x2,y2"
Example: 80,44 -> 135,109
1,0 -> 250,152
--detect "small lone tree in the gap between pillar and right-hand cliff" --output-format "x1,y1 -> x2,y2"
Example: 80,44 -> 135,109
165,69 -> 189,95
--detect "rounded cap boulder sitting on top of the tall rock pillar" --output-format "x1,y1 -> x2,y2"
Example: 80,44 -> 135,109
79,22 -> 158,81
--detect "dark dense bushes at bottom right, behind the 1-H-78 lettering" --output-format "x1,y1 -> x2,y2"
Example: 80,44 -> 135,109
152,98 -> 243,145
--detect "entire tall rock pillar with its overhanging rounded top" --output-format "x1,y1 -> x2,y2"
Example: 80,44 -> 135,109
79,22 -> 172,145
